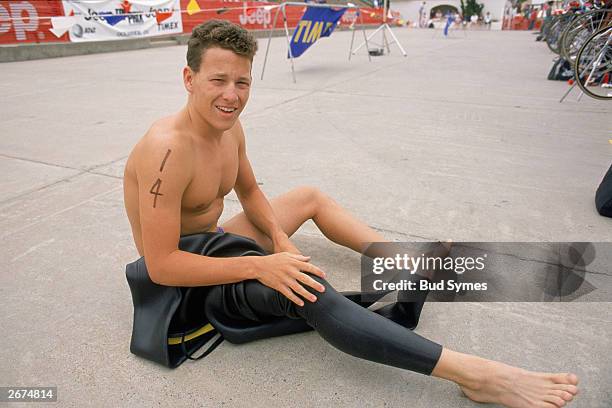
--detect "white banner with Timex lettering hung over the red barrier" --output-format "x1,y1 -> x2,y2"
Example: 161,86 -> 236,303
58,0 -> 183,42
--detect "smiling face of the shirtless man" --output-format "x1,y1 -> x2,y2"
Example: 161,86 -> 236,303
184,47 -> 251,130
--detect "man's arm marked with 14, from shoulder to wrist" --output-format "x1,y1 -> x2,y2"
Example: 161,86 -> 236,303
136,134 -> 258,286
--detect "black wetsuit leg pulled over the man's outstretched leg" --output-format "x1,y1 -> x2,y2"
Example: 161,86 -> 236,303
222,275 -> 442,375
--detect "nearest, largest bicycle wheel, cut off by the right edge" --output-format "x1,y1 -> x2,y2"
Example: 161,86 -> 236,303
574,26 -> 612,100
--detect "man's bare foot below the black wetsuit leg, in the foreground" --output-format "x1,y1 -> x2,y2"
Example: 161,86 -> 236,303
460,360 -> 578,408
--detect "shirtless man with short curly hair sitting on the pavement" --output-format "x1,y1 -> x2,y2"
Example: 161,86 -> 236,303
124,21 -> 578,408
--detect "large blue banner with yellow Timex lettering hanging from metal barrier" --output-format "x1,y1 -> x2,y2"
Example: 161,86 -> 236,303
287,7 -> 346,58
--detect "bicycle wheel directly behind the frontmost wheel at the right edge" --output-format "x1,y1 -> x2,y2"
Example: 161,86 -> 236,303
559,9 -> 612,64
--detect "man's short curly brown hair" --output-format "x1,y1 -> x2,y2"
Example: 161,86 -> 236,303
187,20 -> 257,72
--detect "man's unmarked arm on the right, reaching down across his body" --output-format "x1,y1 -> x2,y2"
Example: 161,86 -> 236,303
232,121 -> 300,254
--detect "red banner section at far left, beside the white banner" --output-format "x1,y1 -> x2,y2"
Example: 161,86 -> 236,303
0,0 -> 68,44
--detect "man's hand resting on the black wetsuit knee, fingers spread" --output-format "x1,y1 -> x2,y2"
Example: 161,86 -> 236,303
253,252 -> 325,306
